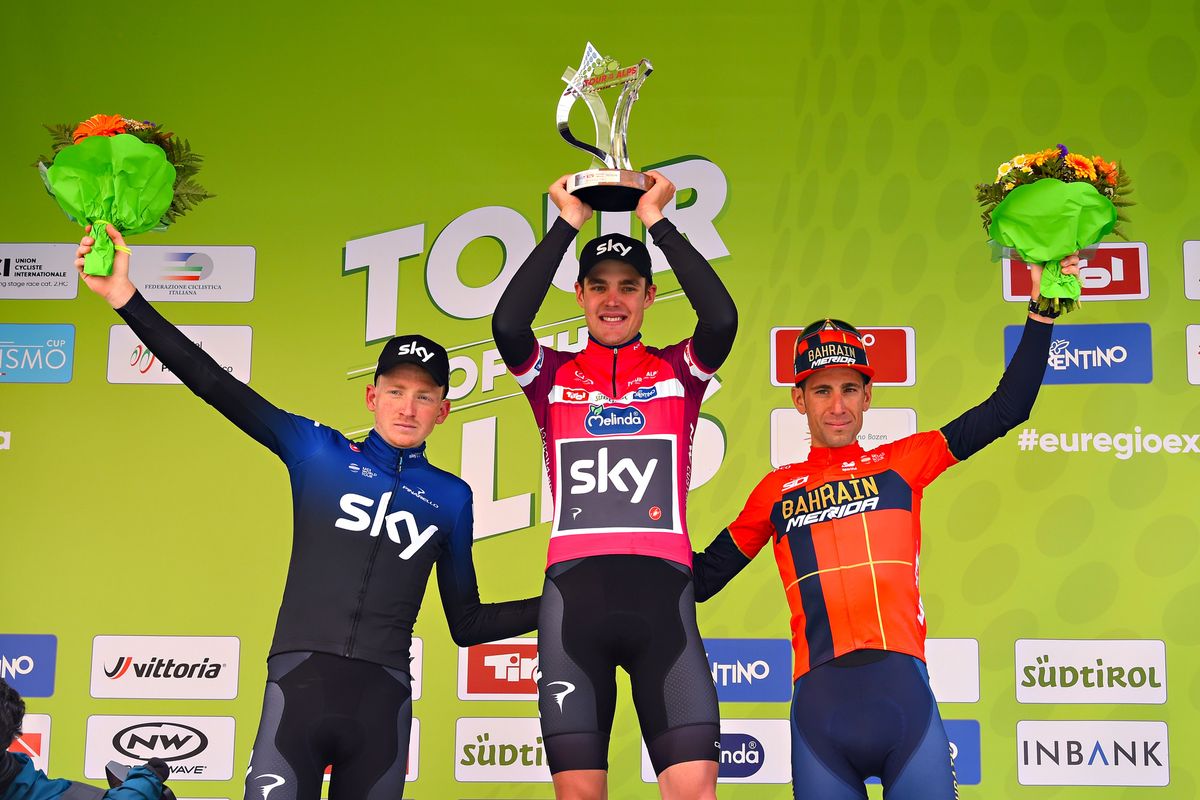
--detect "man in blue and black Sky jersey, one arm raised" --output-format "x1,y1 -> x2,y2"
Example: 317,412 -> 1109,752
76,225 -> 538,800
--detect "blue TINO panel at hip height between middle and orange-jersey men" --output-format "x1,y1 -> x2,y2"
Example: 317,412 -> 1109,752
704,639 -> 792,703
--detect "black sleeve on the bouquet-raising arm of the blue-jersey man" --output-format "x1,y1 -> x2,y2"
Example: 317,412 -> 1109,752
116,291 -> 299,461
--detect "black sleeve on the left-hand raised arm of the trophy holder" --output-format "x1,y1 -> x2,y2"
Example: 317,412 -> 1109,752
492,217 -> 580,368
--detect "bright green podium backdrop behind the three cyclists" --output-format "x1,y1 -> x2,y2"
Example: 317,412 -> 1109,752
0,0 -> 1200,799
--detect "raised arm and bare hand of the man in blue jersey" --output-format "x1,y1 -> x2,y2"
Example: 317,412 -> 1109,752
76,225 -> 312,462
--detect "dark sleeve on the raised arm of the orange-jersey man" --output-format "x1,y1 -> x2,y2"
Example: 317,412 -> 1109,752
942,318 -> 1054,461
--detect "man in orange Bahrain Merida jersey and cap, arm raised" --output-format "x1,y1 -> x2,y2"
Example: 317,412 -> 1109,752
692,255 -> 1079,800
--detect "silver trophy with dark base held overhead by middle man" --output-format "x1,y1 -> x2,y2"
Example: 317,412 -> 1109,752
556,42 -> 654,211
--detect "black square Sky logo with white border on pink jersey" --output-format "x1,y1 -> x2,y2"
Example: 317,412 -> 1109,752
553,435 -> 679,535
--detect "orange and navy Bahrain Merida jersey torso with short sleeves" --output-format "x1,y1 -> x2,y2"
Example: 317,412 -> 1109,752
728,431 -> 956,679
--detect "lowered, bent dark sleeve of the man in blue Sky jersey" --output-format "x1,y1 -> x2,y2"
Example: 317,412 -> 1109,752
438,503 -> 541,648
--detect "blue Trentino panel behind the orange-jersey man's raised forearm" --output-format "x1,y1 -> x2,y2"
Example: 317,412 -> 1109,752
1004,323 -> 1154,384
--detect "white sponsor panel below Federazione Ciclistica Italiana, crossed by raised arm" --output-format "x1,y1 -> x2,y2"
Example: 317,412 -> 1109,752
108,325 -> 252,384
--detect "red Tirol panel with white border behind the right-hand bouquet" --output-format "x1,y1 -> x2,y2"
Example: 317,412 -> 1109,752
1003,241 -> 1150,302
